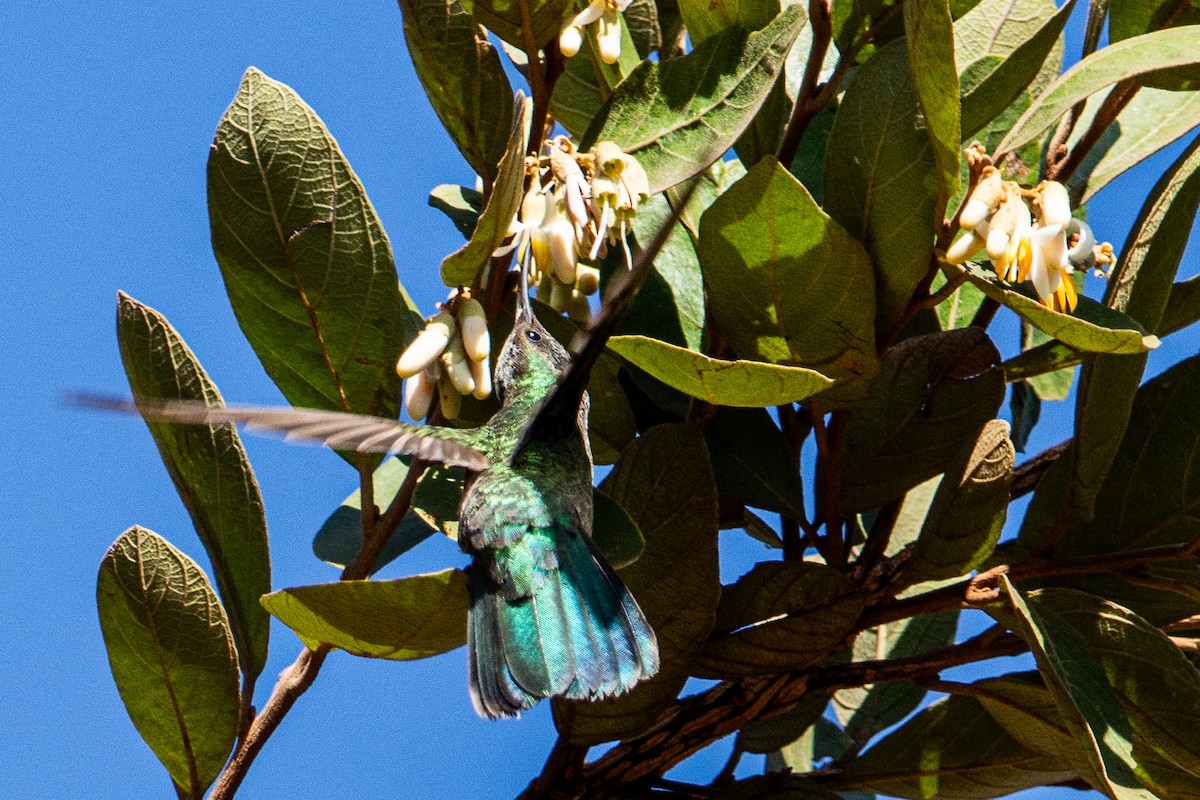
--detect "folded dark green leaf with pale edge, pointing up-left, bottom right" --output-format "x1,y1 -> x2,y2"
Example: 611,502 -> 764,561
1001,576 -> 1153,800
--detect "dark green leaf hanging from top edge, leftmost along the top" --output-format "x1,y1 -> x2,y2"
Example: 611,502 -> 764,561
400,0 -> 512,186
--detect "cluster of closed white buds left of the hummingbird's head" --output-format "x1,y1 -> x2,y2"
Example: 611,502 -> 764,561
396,290 -> 492,420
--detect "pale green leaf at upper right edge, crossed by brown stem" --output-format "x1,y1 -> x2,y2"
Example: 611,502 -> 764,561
1068,89 -> 1200,205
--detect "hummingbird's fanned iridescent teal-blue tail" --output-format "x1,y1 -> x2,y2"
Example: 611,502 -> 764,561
467,529 -> 659,717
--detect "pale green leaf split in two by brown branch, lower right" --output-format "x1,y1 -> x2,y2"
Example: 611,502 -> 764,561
833,609 -> 959,742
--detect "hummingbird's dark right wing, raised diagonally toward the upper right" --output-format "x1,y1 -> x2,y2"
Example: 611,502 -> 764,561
509,179 -> 700,463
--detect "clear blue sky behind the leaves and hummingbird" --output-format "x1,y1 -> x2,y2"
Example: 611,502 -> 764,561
0,0 -> 1196,798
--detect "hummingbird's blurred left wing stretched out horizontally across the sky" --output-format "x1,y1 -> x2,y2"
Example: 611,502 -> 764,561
67,393 -> 491,471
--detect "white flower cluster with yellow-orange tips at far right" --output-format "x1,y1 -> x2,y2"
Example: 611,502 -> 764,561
946,164 -> 1114,312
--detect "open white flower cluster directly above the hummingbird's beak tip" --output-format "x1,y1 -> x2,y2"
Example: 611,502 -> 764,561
494,137 -> 649,321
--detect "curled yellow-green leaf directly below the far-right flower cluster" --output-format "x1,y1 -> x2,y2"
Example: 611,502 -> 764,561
950,264 -> 1159,354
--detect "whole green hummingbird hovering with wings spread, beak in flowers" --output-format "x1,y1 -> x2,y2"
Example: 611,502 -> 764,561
73,184 -> 691,717
